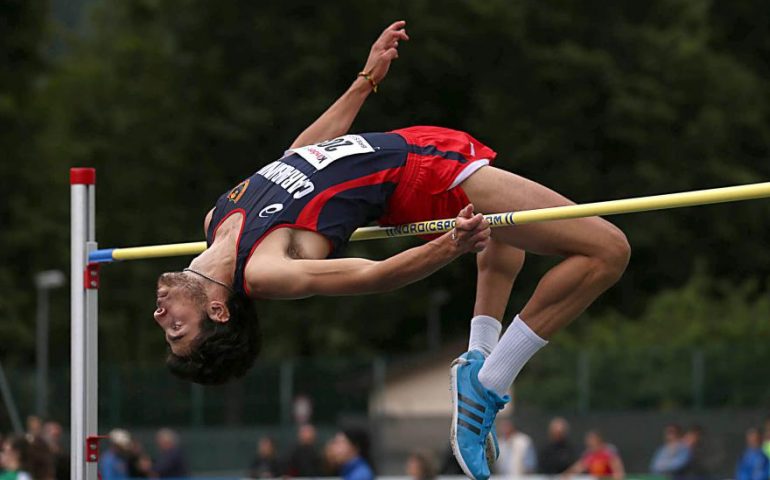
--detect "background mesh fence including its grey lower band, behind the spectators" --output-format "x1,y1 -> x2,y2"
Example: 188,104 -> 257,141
0,342 -> 770,475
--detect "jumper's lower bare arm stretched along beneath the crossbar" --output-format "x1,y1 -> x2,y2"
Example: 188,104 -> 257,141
249,205 -> 491,299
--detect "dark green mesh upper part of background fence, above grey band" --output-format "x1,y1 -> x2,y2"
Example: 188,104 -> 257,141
0,342 -> 770,431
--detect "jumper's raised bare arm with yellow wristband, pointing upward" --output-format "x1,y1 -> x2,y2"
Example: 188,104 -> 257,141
289,20 -> 409,148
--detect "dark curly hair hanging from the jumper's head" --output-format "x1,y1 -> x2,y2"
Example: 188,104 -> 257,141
166,293 -> 262,385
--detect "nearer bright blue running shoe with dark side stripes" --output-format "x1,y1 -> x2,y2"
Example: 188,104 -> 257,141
450,351 -> 510,480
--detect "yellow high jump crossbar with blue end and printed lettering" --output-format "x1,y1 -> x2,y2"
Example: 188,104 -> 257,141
105,182 -> 770,260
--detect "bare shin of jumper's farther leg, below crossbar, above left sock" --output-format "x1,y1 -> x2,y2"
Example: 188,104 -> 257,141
473,238 -> 524,321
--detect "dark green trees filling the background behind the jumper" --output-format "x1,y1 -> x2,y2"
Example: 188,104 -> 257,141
0,0 -> 770,376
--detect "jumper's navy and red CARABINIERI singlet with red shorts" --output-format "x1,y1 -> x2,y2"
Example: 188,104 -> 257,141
206,127 -> 496,293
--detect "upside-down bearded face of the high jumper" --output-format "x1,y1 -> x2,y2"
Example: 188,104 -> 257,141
153,272 -> 206,356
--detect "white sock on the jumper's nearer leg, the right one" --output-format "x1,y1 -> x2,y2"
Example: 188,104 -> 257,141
479,315 -> 548,396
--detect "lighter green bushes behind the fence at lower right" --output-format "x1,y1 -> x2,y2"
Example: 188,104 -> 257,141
516,267 -> 770,409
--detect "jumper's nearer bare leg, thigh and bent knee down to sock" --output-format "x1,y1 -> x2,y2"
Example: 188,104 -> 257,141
462,167 -> 630,338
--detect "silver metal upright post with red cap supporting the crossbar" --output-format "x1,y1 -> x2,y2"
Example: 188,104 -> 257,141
70,168 -> 98,480
